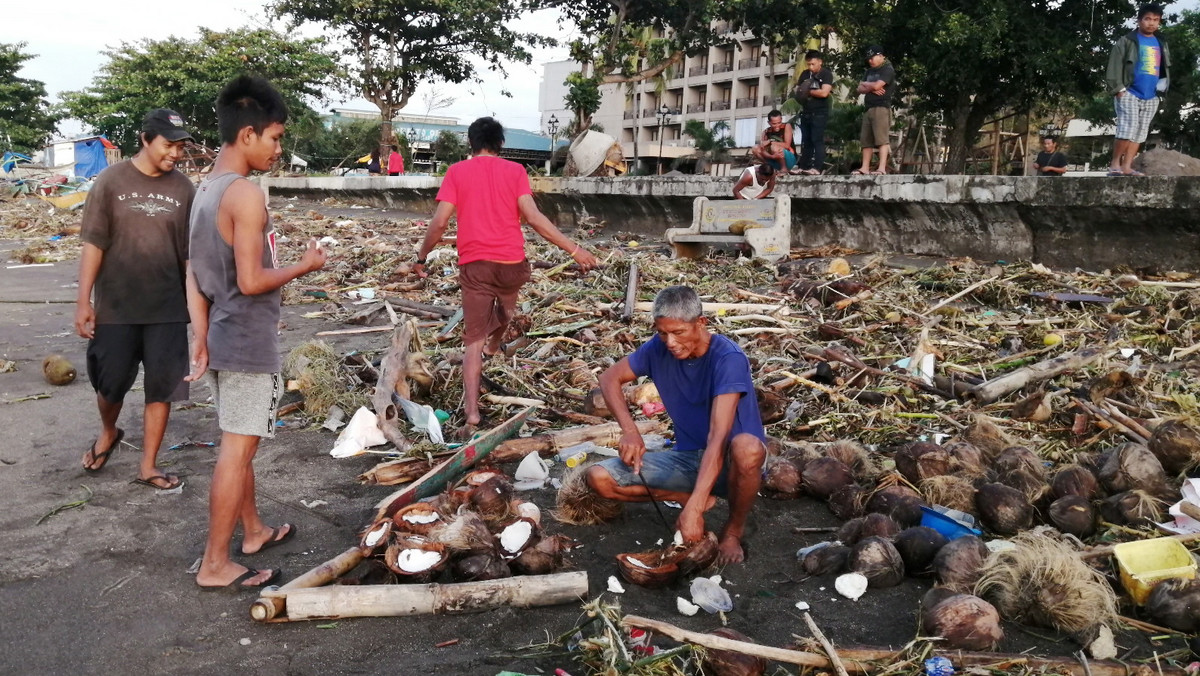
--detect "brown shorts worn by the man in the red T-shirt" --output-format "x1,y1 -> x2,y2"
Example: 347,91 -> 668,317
458,261 -> 529,345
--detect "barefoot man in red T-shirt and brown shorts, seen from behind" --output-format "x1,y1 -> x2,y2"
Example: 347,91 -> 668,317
414,118 -> 598,439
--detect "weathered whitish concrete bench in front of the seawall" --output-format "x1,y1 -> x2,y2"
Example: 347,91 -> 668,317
667,195 -> 792,263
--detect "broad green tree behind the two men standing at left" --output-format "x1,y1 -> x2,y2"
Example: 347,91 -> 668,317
62,28 -> 338,152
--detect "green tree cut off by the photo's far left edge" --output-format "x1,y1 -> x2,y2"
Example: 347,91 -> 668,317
0,42 -> 59,152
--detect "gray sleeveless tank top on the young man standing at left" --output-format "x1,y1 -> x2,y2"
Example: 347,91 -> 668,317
188,173 -> 281,373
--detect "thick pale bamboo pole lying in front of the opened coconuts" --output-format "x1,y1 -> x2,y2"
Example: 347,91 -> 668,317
274,570 -> 588,620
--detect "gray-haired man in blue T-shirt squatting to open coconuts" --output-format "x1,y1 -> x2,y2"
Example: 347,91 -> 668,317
587,286 -> 767,564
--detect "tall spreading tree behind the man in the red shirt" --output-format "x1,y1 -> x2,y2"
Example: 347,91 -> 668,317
270,0 -> 554,151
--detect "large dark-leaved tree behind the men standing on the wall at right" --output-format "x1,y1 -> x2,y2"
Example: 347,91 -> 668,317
830,0 -> 1134,173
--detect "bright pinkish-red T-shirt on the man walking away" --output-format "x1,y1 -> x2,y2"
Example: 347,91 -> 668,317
438,155 -> 533,265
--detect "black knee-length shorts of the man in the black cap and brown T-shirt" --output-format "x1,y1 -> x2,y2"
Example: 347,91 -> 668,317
88,322 -> 188,403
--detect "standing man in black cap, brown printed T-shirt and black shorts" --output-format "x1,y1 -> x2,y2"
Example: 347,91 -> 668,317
74,108 -> 196,490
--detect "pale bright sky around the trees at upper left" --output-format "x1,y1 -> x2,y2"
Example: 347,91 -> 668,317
4,0 -> 566,136
